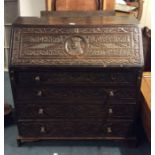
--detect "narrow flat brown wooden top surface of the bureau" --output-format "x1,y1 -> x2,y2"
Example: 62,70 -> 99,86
14,16 -> 138,26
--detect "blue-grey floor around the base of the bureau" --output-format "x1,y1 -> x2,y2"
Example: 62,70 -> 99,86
4,73 -> 151,155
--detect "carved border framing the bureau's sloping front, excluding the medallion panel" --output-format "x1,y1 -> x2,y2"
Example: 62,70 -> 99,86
11,25 -> 142,66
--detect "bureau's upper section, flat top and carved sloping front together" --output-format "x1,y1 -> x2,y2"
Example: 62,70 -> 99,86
10,16 -> 143,67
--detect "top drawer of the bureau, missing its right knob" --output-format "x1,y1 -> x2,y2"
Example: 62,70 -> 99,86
14,69 -> 136,85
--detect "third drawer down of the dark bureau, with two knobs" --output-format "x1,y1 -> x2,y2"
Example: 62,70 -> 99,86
16,103 -> 136,119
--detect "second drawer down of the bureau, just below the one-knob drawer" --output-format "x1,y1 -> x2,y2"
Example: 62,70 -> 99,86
16,86 -> 136,101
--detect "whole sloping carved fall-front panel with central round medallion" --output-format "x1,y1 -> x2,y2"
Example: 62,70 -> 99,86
11,25 -> 142,66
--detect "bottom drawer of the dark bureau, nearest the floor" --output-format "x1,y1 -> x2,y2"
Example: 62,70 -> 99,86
18,119 -> 134,137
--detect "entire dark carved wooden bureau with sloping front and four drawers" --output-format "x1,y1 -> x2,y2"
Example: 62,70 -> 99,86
9,16 -> 143,143
